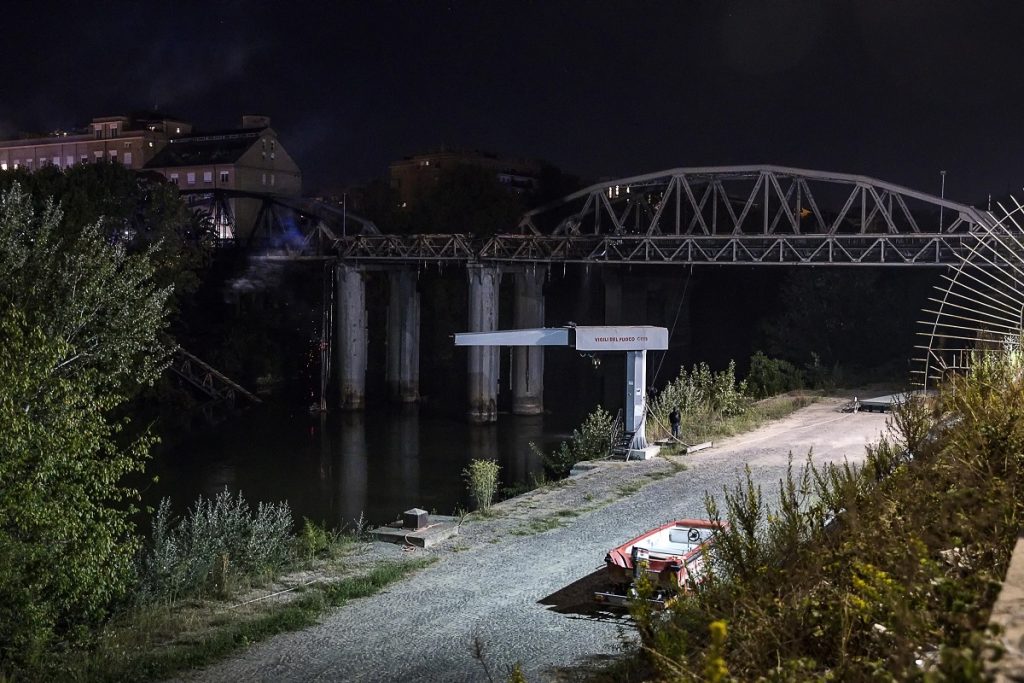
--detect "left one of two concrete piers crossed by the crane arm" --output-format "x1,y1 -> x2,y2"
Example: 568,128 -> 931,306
466,264 -> 502,424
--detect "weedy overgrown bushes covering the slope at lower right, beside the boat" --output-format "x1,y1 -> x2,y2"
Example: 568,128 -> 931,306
636,356 -> 1024,680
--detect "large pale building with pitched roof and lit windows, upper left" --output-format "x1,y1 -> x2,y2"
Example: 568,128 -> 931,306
0,113 -> 302,239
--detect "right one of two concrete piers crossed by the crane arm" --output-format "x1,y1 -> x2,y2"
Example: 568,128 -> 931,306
512,266 -> 547,415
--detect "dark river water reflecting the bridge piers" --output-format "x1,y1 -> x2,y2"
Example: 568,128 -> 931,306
148,405 -> 579,527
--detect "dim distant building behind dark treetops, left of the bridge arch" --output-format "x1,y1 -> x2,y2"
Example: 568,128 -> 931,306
389,148 -> 541,206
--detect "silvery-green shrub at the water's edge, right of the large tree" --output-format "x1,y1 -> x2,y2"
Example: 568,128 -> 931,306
141,489 -> 293,600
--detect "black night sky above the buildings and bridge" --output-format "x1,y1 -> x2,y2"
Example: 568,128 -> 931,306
0,0 -> 1024,202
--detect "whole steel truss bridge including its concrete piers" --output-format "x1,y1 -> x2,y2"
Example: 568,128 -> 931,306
220,165 -> 993,422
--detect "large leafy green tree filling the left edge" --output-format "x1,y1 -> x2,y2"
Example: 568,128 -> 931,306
0,184 -> 171,661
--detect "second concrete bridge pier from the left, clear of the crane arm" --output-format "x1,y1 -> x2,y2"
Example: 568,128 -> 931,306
386,269 -> 420,403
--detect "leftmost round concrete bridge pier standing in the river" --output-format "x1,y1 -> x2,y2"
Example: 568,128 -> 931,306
336,264 -> 367,411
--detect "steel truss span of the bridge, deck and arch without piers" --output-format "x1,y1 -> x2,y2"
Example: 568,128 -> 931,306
258,166 -> 1007,266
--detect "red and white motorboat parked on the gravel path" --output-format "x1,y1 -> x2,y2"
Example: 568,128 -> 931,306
594,519 -> 724,607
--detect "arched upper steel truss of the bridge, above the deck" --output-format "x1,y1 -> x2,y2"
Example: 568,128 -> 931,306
519,165 -> 988,237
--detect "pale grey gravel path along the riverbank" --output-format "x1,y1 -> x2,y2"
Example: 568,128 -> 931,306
185,400 -> 885,681
